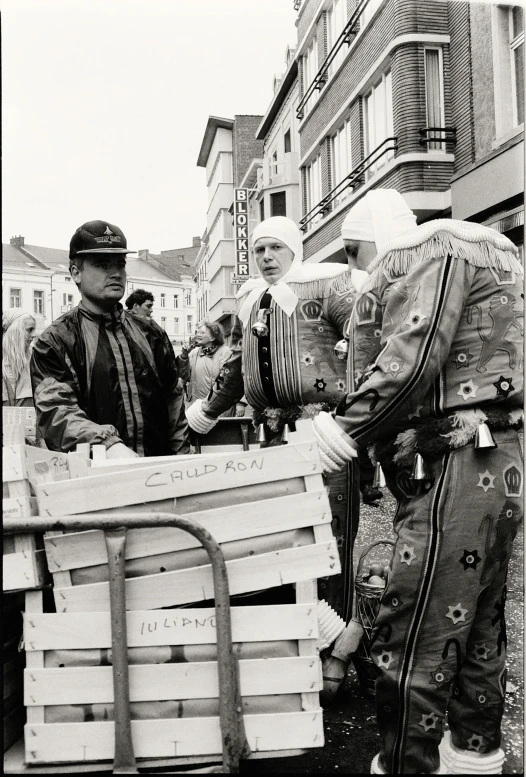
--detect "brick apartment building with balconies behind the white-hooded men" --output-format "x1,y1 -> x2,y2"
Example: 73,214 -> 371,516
295,0 -> 524,261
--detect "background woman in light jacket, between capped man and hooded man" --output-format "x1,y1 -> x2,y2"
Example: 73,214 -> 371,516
187,321 -> 232,405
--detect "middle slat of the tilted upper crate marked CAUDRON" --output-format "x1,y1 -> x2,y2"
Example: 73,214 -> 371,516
45,489 -> 331,572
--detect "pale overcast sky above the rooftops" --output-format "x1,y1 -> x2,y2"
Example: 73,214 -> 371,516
0,0 -> 297,253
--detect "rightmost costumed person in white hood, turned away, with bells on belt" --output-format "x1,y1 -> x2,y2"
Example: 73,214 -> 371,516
318,190 -> 524,774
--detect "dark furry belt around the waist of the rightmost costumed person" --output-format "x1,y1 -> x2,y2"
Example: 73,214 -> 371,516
369,408 -> 524,466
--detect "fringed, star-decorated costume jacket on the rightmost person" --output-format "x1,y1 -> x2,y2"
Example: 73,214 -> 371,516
342,226 -> 524,453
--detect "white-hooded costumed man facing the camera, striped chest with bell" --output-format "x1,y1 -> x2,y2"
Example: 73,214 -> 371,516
187,216 -> 366,640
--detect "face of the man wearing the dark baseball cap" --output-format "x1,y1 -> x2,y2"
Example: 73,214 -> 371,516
71,254 -> 126,311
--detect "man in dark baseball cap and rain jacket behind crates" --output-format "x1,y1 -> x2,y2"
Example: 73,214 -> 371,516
31,221 -> 190,458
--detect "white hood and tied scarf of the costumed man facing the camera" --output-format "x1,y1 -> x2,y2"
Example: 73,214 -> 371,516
236,216 -> 349,328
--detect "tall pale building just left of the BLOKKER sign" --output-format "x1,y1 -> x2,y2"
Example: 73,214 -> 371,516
195,115 -> 263,338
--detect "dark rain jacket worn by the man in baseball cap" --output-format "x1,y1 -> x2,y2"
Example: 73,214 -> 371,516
31,303 -> 190,456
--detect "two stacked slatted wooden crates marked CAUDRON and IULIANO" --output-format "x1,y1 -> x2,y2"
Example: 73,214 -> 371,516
19,422 -> 340,766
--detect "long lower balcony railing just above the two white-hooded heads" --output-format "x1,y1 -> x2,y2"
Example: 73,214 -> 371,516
300,137 -> 398,232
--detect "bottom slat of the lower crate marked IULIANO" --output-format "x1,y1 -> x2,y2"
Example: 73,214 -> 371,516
25,709 -> 324,764
